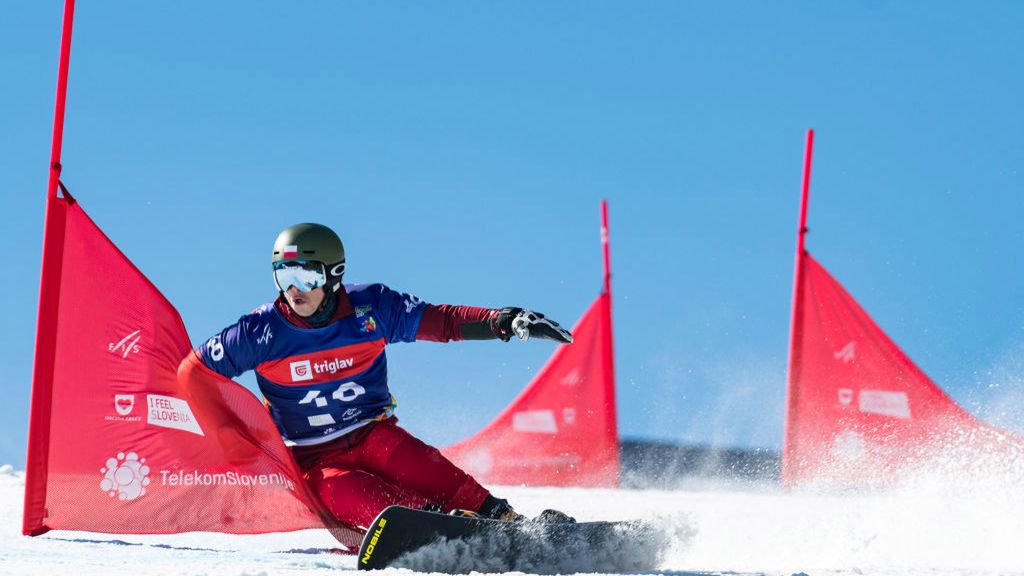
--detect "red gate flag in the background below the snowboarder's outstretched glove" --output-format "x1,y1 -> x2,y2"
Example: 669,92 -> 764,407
443,292 -> 618,486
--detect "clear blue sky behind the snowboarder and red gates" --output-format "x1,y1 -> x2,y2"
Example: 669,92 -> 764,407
0,0 -> 1024,467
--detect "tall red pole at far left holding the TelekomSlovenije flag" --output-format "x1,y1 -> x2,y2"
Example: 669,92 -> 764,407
22,0 -> 75,536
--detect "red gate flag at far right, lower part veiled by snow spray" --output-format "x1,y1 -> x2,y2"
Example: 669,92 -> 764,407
782,252 -> 1024,486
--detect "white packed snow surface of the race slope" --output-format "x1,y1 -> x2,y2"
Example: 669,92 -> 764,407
0,466 -> 1024,576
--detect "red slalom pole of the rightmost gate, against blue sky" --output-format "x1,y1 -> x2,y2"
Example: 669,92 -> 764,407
781,130 -> 814,488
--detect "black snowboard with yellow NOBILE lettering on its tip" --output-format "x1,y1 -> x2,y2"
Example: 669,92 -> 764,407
356,506 -> 662,574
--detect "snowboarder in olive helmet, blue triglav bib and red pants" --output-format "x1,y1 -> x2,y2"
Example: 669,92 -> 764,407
178,223 -> 572,527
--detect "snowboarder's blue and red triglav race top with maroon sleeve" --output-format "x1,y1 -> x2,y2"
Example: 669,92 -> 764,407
196,284 -> 497,446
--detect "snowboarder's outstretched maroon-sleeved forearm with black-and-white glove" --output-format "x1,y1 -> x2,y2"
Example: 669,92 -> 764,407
416,304 -> 572,344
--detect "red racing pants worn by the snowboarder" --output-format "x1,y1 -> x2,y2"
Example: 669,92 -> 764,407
292,417 -> 489,527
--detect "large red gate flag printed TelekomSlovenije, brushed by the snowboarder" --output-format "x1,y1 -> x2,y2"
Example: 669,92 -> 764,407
24,192 -> 358,544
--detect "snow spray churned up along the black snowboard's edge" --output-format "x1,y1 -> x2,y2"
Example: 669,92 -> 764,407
391,512 -> 694,574
